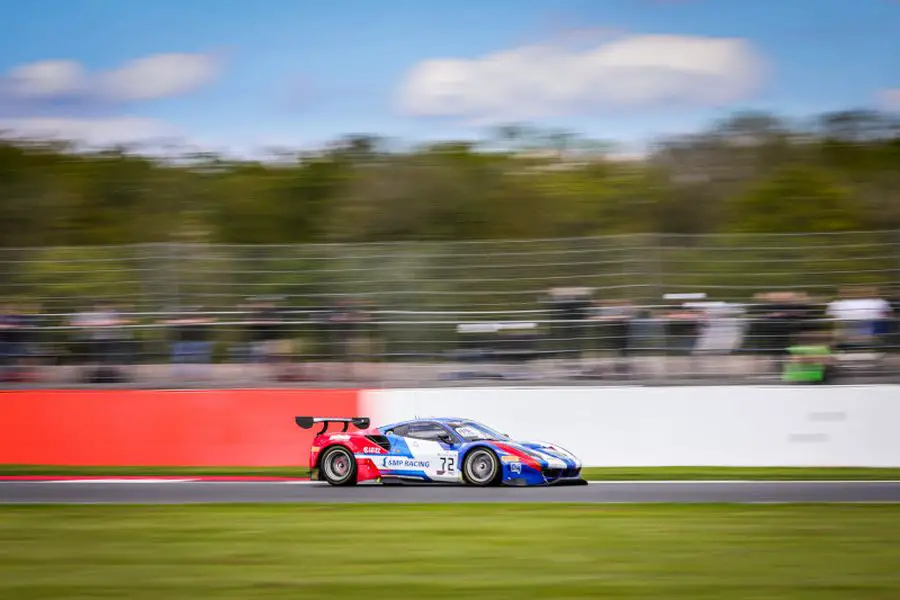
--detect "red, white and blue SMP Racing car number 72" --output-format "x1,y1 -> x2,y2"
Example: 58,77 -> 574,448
294,416 -> 587,487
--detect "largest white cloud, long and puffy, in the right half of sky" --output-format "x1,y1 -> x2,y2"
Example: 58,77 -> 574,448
399,35 -> 764,121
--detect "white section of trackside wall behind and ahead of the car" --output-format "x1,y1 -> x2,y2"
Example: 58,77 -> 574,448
361,386 -> 900,467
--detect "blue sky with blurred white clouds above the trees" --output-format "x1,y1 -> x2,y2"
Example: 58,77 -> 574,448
0,0 -> 900,155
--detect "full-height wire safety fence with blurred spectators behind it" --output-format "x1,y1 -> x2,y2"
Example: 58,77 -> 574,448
0,232 -> 900,387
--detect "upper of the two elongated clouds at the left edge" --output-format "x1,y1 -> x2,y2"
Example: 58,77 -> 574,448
0,54 -> 219,102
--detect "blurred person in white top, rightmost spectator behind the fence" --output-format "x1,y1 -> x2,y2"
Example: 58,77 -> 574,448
827,287 -> 891,350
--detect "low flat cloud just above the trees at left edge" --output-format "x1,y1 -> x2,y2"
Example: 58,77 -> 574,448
0,117 -> 178,146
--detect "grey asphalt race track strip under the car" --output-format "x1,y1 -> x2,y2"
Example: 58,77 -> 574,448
0,478 -> 900,504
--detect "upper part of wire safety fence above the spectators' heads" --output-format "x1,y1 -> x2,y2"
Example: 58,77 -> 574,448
0,232 -> 900,314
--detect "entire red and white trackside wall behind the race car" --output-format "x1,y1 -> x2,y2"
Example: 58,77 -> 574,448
0,386 -> 900,467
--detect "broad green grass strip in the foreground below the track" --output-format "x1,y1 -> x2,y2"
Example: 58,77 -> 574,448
0,504 -> 900,600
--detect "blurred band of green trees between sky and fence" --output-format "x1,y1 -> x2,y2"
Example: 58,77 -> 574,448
0,111 -> 900,247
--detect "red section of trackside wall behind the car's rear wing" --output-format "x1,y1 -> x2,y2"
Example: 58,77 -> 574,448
0,389 -> 359,467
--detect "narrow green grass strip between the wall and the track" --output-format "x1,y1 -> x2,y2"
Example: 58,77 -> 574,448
0,465 -> 900,481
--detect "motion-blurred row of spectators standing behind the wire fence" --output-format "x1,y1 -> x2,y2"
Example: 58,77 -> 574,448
0,287 -> 900,384
